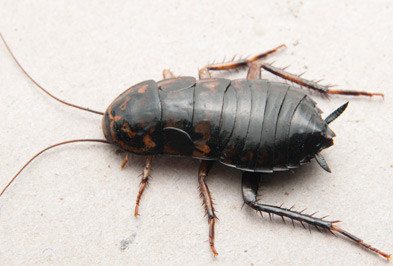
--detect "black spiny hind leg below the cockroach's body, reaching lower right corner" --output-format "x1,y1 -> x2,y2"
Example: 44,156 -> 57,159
242,172 -> 392,260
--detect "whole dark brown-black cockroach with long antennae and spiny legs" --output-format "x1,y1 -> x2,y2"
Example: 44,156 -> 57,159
0,32 -> 392,260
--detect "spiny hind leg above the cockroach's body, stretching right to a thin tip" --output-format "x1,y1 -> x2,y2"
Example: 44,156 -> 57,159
261,64 -> 384,97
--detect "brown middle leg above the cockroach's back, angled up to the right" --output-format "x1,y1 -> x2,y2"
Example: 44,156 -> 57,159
199,44 -> 286,79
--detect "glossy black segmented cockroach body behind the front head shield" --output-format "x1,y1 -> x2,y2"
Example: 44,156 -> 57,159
157,77 -> 322,172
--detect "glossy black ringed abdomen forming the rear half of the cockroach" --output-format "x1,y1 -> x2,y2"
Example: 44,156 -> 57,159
219,80 -> 322,172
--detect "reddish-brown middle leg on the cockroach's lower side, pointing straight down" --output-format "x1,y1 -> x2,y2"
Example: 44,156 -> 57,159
198,161 -> 218,256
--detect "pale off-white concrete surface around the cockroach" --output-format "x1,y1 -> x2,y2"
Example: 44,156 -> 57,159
0,0 -> 393,265
